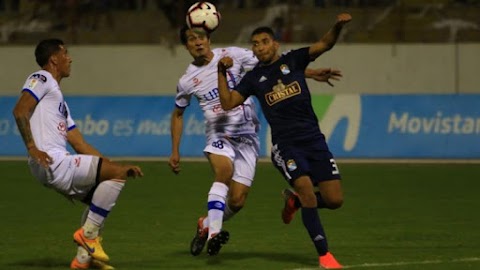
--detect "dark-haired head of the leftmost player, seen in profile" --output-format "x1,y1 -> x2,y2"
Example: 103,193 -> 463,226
35,38 -> 72,77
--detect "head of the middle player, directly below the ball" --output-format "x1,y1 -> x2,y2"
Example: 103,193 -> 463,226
180,25 -> 211,58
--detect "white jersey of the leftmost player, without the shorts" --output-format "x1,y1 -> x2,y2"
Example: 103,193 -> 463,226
23,70 -> 75,156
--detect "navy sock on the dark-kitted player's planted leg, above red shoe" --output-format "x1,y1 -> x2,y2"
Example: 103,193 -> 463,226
302,208 -> 328,256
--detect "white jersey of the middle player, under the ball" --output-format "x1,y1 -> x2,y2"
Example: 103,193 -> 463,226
175,47 -> 259,138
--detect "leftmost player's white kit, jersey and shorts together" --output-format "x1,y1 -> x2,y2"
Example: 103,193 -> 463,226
23,70 -> 99,200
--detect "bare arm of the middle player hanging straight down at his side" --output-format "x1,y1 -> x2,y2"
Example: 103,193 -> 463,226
168,107 -> 185,174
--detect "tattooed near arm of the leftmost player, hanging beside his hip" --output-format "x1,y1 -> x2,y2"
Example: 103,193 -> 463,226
13,91 -> 53,167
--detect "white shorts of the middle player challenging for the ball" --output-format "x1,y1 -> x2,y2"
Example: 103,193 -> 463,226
203,135 -> 260,187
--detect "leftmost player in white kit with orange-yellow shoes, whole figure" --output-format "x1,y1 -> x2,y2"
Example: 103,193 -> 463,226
13,39 -> 143,269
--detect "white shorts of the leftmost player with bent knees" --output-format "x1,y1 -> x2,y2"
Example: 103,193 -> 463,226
28,153 -> 100,201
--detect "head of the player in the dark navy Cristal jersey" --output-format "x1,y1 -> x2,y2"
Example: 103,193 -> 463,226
250,26 -> 280,64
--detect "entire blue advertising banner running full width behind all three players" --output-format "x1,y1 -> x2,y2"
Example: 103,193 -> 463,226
0,94 -> 480,159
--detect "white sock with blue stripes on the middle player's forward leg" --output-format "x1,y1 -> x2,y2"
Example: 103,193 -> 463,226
208,182 -> 228,239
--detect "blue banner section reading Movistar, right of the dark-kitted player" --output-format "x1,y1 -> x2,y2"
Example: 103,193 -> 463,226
313,95 -> 480,158
